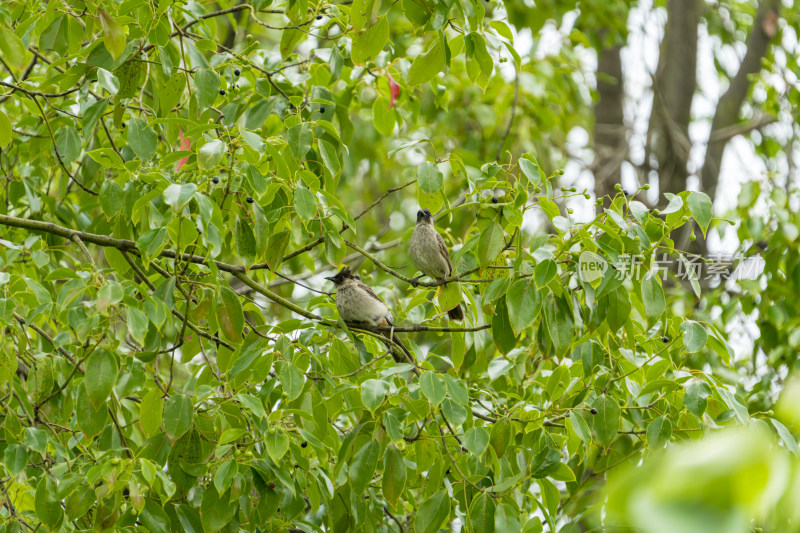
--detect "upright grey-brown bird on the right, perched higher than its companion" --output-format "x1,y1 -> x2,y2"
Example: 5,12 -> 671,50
409,209 -> 464,320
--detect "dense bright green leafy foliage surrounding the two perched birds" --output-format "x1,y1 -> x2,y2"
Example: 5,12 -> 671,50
0,0 -> 800,533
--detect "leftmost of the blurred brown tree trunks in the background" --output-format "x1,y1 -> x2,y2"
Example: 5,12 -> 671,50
592,45 -> 628,202
